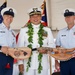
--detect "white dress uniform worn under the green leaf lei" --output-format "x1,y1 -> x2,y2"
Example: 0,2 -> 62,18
18,24 -> 55,75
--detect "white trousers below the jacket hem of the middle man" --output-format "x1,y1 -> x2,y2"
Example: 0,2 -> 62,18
24,69 -> 48,75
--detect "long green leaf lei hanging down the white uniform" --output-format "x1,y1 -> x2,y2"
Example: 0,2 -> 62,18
26,23 -> 44,73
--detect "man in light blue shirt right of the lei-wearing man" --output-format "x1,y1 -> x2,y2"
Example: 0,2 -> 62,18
55,8 -> 75,75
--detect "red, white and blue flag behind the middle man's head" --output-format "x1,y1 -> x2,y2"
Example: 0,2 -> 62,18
41,1 -> 47,26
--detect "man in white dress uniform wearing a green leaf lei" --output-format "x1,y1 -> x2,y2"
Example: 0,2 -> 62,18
18,7 -> 55,75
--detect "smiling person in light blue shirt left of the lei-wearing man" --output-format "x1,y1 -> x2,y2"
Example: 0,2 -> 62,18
0,7 -> 16,75
